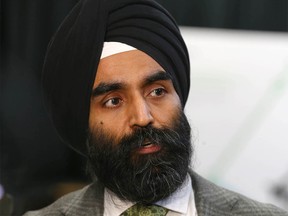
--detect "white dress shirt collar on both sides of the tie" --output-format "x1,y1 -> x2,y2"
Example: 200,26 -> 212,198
104,175 -> 197,216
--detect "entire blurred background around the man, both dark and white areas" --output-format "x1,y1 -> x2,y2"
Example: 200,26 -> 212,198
0,0 -> 288,216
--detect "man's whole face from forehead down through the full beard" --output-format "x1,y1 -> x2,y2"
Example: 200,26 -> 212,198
89,50 -> 191,203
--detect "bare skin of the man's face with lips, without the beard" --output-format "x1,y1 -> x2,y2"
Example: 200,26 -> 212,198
89,50 -> 181,143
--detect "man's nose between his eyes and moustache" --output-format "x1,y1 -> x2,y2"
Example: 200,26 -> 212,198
129,97 -> 154,128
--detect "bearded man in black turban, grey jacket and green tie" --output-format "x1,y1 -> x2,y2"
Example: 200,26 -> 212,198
27,0 -> 288,216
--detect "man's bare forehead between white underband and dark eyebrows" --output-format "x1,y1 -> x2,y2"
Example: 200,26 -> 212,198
94,50 -> 164,87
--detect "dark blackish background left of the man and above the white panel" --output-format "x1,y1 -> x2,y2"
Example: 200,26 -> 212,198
0,0 -> 288,215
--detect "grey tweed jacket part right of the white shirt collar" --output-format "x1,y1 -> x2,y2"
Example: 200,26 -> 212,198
191,172 -> 288,216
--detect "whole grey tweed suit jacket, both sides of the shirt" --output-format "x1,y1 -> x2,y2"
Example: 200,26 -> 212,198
24,172 -> 288,216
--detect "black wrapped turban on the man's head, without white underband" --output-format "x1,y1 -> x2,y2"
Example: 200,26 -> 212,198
43,0 -> 190,155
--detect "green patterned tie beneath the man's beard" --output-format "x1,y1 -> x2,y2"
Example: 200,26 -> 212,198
120,203 -> 168,216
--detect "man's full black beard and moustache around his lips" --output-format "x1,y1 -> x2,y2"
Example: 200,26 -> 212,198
88,111 -> 192,203
